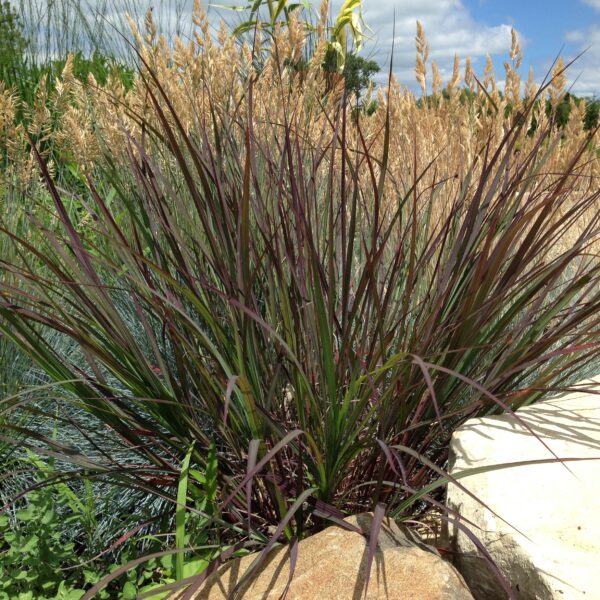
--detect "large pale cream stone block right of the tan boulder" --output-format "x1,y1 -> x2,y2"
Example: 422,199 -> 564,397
447,378 -> 600,600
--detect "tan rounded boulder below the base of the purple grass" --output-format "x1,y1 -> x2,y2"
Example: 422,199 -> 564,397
186,514 -> 473,600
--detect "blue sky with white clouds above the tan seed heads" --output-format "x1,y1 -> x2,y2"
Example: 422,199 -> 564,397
11,0 -> 600,96
